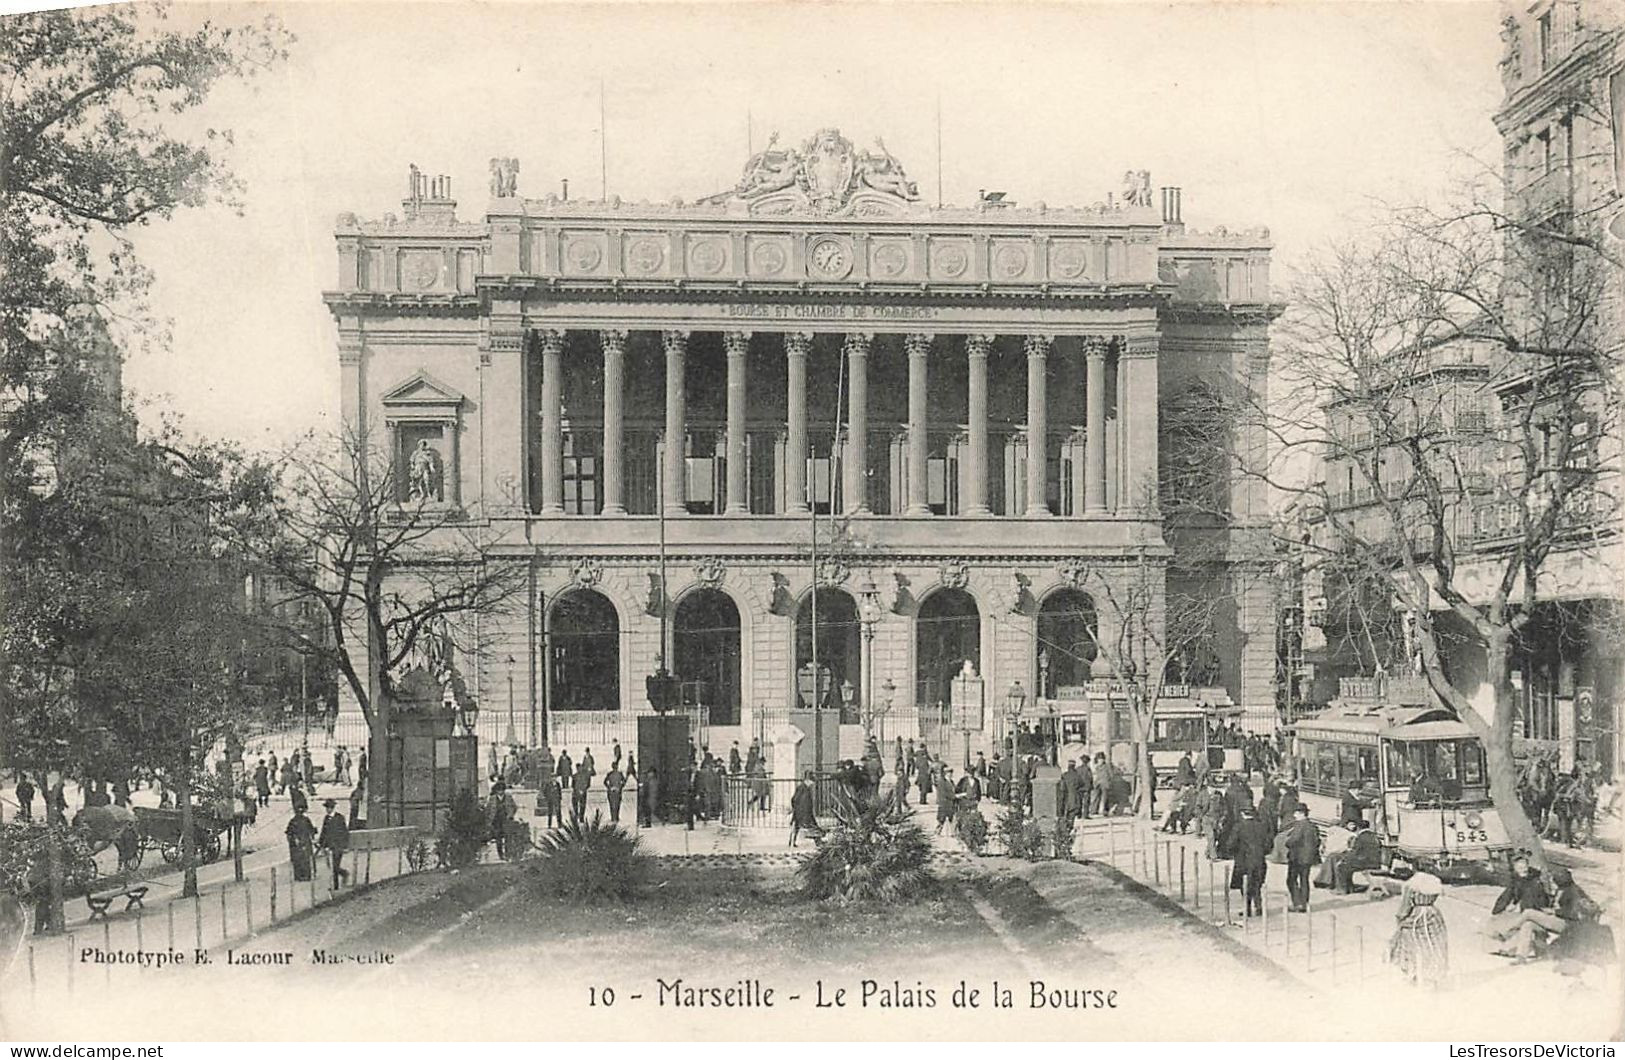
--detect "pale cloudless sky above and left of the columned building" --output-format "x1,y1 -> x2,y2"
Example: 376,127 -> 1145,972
108,0 -> 1500,447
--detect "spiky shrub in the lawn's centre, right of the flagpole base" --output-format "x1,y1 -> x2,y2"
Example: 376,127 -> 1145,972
800,793 -> 931,901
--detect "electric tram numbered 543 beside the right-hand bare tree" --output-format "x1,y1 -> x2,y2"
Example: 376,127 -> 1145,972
1292,706 -> 1511,871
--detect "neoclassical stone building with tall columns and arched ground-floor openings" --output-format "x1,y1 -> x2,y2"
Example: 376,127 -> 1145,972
325,130 -> 1277,760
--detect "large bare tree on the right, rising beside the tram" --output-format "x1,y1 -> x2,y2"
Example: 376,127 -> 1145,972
1259,182 -> 1619,850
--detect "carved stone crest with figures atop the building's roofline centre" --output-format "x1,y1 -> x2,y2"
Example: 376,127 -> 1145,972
728,128 -> 920,216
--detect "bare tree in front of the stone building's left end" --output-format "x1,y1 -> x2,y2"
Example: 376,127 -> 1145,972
241,437 -> 528,816
